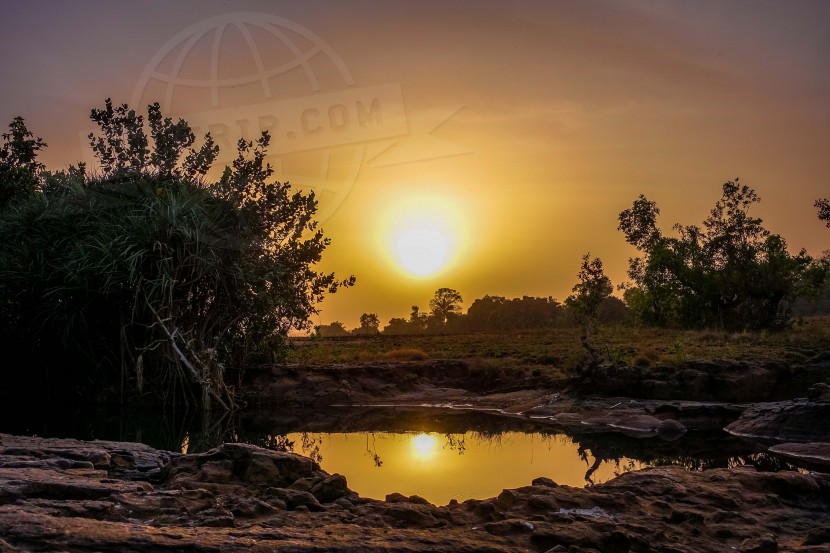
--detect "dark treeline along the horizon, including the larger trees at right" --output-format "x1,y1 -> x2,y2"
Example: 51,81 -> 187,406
316,179 -> 830,341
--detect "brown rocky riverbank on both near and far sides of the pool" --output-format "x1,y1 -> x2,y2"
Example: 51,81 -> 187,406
0,329 -> 830,553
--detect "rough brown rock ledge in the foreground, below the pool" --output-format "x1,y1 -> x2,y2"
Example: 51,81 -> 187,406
0,434 -> 830,553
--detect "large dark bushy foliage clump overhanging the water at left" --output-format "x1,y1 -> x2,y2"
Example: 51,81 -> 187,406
0,100 -> 354,408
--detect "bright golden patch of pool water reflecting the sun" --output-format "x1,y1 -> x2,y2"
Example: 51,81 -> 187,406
221,432 -> 645,505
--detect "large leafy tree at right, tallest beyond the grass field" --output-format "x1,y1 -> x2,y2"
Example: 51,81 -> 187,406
618,179 -> 827,329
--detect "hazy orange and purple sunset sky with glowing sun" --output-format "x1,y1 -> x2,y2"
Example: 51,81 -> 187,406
0,0 -> 830,328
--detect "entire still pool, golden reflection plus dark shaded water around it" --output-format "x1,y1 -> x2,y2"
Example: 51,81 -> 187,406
0,406 -> 798,505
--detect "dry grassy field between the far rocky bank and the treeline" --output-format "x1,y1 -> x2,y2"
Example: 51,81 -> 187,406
288,318 -> 830,374
